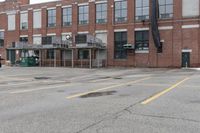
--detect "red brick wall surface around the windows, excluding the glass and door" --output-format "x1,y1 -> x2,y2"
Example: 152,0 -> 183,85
0,0 -> 200,67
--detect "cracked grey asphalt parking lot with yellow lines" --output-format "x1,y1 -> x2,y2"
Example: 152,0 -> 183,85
0,67 -> 200,133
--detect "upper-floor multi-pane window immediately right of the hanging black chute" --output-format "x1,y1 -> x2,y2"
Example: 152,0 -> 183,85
159,0 -> 173,18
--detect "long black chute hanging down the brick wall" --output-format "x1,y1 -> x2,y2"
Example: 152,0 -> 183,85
151,0 -> 162,49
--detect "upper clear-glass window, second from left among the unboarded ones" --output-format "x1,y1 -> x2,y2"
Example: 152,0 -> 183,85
63,7 -> 72,26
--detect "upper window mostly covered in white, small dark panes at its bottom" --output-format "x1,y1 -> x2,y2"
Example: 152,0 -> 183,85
20,12 -> 28,30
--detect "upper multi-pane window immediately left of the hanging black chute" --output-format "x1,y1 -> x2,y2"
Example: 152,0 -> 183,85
135,0 -> 149,21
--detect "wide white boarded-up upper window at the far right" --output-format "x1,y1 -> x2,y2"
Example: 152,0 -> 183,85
182,0 -> 199,17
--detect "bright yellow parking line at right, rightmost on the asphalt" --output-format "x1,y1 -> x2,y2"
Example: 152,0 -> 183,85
141,77 -> 190,105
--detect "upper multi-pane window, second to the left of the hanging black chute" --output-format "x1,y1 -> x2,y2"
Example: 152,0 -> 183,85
115,0 -> 127,23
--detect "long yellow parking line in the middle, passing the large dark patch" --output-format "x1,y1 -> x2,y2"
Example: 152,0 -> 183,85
66,77 -> 150,99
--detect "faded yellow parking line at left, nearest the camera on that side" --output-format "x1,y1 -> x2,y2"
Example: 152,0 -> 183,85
10,84 -> 72,94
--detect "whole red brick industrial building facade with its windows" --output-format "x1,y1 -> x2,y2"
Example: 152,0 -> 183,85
0,0 -> 200,67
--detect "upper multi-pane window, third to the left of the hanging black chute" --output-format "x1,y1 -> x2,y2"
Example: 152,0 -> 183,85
96,3 -> 107,24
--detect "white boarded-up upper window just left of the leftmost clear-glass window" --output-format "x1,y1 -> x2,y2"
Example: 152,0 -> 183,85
33,10 -> 42,29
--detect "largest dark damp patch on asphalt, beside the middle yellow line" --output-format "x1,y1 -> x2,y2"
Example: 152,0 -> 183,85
80,91 -> 117,98
